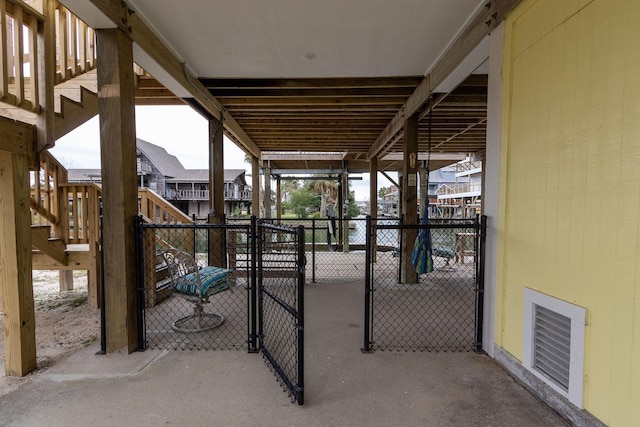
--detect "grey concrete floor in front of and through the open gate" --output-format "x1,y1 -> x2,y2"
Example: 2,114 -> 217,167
0,284 -> 567,426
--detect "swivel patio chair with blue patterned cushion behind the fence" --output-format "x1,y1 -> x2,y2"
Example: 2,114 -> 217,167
162,248 -> 235,332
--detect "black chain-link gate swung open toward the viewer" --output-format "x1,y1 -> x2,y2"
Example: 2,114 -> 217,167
257,222 -> 305,405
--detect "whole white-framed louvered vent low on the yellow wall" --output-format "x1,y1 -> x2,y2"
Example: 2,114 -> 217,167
522,288 -> 586,408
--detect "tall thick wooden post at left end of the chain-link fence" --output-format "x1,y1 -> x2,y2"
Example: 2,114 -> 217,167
96,29 -> 138,353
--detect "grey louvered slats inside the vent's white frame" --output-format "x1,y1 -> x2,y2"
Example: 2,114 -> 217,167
533,305 -> 571,391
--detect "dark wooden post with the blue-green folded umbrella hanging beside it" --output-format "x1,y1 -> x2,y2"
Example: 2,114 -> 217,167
402,115 -> 418,283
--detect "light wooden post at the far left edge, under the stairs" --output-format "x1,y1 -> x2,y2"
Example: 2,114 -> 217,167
0,151 -> 36,377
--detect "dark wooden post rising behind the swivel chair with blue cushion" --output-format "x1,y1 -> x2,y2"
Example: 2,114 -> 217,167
208,119 -> 227,267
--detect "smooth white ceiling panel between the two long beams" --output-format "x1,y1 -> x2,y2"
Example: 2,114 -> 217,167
128,0 -> 485,78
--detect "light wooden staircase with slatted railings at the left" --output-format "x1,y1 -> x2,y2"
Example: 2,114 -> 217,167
0,0 -> 191,307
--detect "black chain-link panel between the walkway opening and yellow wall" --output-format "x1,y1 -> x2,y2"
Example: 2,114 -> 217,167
363,217 -> 486,351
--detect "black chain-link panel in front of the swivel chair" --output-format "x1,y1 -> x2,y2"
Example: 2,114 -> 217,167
136,219 -> 257,351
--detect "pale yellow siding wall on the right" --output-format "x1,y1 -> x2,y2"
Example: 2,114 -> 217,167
496,0 -> 640,426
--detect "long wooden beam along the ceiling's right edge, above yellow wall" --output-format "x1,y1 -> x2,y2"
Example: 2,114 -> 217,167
367,0 -> 521,159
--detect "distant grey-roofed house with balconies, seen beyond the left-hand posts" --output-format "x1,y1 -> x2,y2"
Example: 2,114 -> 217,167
69,139 -> 252,218
